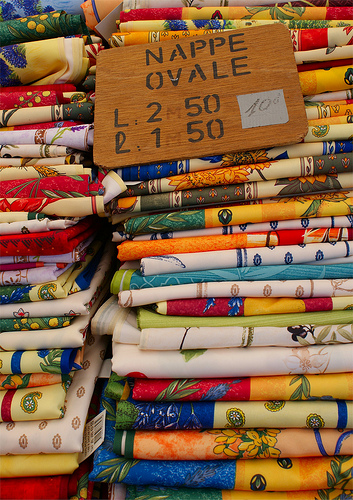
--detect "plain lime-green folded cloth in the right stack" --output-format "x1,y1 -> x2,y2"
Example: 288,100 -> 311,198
137,307 -> 353,330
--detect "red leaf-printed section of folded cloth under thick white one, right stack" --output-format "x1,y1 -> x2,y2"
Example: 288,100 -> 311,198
132,377 -> 251,401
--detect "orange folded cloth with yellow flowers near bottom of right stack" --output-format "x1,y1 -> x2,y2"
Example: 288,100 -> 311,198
113,428 -> 353,460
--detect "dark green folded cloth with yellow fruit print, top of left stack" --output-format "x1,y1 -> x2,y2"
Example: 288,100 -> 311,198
0,11 -> 90,47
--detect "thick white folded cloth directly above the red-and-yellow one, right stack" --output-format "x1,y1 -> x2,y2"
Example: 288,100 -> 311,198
112,343 -> 353,378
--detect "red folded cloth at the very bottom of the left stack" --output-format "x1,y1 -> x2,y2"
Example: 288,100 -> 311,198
0,475 -> 70,500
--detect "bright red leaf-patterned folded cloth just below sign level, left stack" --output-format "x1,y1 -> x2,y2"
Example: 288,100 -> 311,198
0,174 -> 104,199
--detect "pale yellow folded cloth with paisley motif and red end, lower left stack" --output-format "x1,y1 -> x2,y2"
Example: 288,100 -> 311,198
0,383 -> 68,422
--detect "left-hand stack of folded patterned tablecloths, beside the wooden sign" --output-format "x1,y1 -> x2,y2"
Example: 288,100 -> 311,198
0,2 -> 125,499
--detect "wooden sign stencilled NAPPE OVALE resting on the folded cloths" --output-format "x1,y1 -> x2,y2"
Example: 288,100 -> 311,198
93,24 -> 307,168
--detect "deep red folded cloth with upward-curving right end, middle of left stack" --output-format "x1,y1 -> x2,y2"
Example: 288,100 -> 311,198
0,217 -> 100,255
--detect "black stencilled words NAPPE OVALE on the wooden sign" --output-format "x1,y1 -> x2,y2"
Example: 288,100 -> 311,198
145,33 -> 251,90
